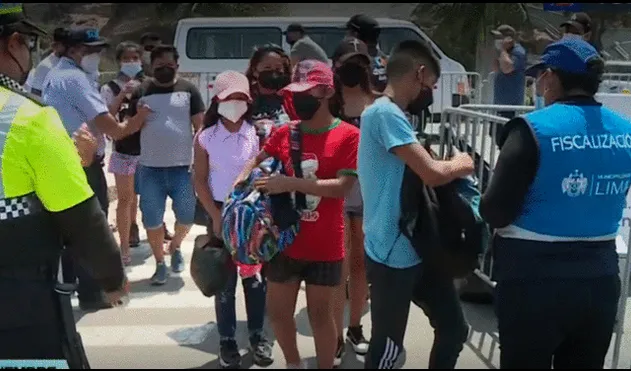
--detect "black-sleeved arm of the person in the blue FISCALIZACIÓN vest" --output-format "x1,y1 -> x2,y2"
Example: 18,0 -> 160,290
480,117 -> 539,228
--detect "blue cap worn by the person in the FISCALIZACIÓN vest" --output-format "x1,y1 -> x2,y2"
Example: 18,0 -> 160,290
526,37 -> 600,77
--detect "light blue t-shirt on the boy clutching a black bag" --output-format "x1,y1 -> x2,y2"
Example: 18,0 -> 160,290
357,97 -> 421,269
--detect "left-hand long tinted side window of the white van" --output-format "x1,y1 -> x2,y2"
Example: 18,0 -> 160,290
186,27 -> 282,59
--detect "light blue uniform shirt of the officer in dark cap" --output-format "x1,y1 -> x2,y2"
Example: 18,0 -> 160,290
42,57 -> 109,156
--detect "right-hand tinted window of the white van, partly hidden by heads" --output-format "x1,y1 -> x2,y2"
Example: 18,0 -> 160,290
305,27 -> 440,58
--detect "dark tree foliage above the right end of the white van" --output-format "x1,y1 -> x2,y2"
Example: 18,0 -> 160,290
412,3 -> 532,69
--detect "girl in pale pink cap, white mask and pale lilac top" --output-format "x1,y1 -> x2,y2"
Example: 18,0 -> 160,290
194,71 -> 273,368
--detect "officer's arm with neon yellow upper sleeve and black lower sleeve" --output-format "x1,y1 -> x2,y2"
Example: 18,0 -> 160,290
26,107 -> 125,293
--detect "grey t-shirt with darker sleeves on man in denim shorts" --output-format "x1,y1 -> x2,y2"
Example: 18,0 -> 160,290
130,79 -> 204,167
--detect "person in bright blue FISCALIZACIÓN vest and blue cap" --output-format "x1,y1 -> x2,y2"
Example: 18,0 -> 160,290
480,37 -> 631,369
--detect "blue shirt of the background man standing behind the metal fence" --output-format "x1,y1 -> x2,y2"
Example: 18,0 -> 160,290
493,44 -> 526,106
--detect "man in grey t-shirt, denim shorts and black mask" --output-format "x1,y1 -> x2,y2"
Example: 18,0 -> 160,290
131,45 -> 204,285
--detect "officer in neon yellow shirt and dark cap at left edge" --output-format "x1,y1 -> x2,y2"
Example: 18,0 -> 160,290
0,3 -> 126,360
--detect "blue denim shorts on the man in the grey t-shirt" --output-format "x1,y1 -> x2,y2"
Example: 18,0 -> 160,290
136,166 -> 196,229
